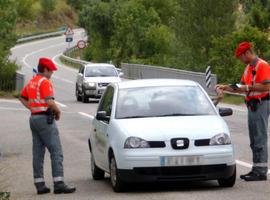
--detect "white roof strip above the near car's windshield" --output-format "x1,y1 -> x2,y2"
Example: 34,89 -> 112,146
115,79 -> 198,89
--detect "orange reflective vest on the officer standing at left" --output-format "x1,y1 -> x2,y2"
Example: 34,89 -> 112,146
26,75 -> 48,113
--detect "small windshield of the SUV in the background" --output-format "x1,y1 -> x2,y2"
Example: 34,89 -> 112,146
85,66 -> 118,77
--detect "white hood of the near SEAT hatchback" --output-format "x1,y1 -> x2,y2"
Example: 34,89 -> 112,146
115,115 -> 229,141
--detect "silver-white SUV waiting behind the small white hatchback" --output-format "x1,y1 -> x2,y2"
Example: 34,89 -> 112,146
75,63 -> 123,103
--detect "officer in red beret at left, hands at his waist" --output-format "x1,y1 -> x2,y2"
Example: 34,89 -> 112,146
20,58 -> 76,194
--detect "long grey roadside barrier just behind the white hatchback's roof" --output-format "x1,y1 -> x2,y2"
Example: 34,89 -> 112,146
121,63 -> 217,95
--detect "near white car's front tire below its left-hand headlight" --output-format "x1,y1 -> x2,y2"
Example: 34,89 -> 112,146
110,156 -> 125,192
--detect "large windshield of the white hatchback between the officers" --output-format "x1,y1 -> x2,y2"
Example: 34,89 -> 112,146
116,86 -> 216,119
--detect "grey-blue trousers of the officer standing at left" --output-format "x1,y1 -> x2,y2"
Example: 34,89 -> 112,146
30,115 -> 64,184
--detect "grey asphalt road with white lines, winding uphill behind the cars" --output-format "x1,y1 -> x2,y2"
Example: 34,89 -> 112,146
0,30 -> 270,200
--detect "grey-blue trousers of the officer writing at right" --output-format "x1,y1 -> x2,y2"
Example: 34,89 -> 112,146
248,101 -> 270,175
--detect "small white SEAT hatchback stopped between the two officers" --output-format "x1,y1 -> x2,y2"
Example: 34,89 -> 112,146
89,79 -> 236,192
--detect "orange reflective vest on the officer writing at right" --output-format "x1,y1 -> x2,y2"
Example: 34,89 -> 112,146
241,58 -> 270,101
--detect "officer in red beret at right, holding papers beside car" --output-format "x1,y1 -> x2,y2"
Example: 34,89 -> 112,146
216,42 -> 270,181
